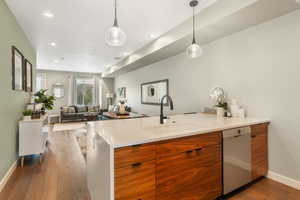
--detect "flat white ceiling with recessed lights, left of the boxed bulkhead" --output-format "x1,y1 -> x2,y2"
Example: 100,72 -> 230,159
6,0 -> 217,73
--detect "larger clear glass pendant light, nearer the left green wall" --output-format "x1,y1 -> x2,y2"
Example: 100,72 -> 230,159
105,0 -> 126,47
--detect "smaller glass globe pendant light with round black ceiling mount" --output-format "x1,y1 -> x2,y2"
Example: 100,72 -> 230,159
186,0 -> 203,58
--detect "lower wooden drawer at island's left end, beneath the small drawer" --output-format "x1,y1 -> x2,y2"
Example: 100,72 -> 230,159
115,161 -> 155,200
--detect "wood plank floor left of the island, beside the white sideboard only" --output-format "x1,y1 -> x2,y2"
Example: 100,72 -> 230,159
0,132 -> 90,200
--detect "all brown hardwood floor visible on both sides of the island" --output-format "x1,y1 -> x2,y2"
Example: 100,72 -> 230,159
0,129 -> 300,200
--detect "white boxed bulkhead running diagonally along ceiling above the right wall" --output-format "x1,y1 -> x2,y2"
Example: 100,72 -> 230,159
102,0 -> 300,77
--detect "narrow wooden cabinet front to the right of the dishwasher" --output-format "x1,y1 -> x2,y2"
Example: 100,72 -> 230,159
251,124 -> 268,180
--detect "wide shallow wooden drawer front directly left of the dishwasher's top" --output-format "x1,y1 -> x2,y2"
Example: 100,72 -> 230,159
156,132 -> 221,158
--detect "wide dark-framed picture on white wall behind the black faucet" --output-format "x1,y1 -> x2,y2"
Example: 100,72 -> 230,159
141,79 -> 169,105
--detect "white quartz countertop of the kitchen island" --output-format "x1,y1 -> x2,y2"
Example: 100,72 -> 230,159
89,113 -> 270,148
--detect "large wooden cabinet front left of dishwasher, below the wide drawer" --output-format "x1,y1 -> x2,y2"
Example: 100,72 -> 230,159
156,145 -> 222,200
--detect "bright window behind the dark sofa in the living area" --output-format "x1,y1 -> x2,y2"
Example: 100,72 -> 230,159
75,78 -> 95,106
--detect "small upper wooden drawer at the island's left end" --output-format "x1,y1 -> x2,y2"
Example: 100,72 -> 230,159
115,144 -> 155,168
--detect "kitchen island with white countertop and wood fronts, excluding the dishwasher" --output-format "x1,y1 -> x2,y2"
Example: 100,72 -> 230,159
87,114 -> 270,200
